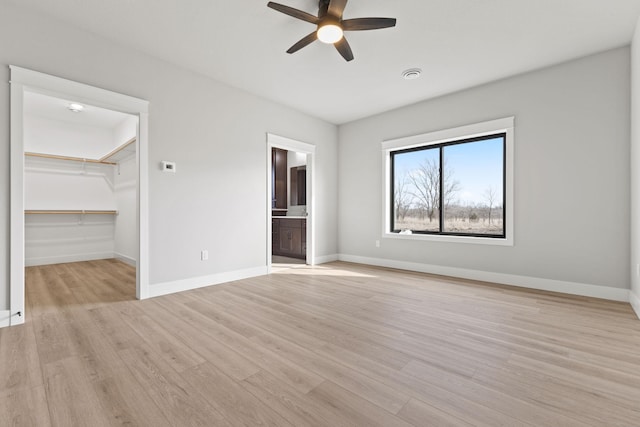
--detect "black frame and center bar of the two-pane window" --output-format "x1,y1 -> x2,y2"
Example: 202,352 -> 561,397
389,131 -> 508,239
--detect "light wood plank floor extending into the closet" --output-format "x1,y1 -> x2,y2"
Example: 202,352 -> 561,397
0,261 -> 640,427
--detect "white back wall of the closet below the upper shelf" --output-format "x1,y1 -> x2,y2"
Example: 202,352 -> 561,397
24,157 -> 117,266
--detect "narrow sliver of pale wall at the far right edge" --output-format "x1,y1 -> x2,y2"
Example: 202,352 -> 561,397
631,16 -> 640,317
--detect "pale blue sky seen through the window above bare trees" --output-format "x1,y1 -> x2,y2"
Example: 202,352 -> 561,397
394,138 -> 503,205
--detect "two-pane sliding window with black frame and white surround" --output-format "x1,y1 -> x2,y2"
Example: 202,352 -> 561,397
383,118 -> 513,244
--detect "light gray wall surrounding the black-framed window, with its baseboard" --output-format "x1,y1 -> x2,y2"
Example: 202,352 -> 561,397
338,48 -> 630,300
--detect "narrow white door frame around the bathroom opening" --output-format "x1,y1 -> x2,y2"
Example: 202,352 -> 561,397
266,133 -> 316,273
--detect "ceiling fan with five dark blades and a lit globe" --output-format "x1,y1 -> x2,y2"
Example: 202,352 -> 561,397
267,0 -> 396,61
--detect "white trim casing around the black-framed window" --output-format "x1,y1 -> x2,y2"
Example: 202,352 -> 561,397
382,117 -> 515,246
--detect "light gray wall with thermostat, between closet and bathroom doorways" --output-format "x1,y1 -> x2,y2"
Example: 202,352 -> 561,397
0,3 -> 337,309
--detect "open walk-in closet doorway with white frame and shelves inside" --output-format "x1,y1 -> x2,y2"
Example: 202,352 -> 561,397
10,66 -> 148,325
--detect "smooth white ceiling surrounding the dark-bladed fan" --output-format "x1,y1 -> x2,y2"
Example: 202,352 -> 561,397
7,0 -> 640,124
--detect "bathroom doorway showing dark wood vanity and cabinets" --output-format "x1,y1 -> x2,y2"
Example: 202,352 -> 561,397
267,134 -> 315,272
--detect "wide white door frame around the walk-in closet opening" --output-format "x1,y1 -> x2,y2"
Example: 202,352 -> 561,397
9,65 -> 149,325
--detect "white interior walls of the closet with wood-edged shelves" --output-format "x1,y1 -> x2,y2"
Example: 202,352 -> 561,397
24,94 -> 137,266
